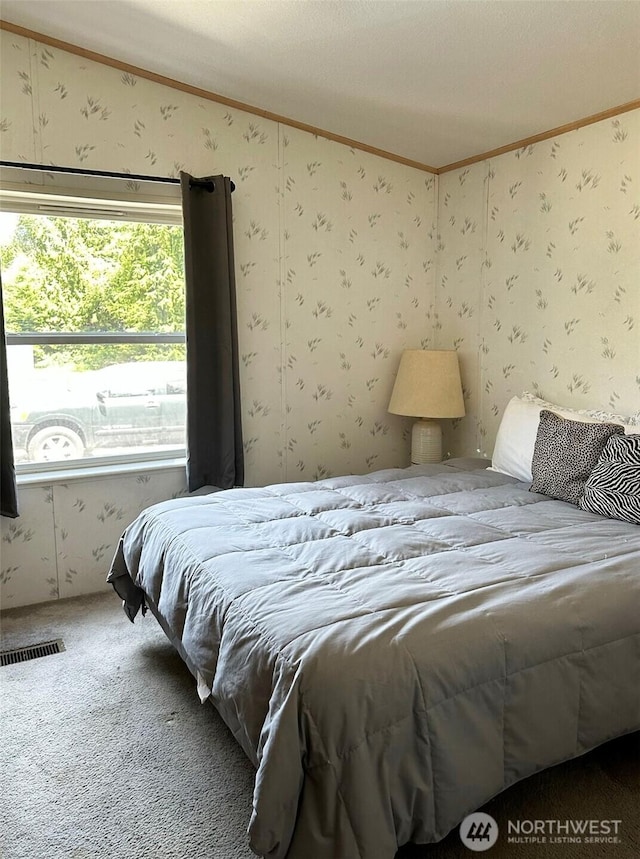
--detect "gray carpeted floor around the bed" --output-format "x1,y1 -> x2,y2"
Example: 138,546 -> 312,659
0,593 -> 640,859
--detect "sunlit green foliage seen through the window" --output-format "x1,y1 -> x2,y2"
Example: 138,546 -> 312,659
0,215 -> 185,370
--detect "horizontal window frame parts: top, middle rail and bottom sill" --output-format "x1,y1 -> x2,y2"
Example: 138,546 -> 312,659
0,179 -> 186,483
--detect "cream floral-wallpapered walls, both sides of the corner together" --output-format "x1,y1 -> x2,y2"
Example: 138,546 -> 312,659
0,32 -> 640,608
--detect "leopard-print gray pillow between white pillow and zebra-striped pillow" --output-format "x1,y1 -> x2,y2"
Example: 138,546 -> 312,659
531,409 -> 624,504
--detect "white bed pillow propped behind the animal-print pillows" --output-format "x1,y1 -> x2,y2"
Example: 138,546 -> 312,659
491,392 -> 638,483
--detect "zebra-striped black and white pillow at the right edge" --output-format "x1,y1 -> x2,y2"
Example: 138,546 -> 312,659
580,435 -> 640,525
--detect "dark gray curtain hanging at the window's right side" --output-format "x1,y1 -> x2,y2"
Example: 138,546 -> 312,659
180,173 -> 244,492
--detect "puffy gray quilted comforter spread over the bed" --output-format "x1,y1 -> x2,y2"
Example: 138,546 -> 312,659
109,463 -> 640,859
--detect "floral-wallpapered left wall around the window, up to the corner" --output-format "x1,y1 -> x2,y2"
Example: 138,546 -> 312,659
0,31 -> 437,607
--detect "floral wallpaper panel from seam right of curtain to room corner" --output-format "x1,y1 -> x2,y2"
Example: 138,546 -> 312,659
281,129 -> 436,480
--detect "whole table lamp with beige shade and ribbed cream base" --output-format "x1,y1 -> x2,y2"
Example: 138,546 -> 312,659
389,349 -> 464,464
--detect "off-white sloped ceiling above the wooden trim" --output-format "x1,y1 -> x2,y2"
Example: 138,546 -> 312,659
0,0 -> 640,167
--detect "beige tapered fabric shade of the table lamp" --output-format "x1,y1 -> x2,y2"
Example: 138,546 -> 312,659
389,349 -> 464,418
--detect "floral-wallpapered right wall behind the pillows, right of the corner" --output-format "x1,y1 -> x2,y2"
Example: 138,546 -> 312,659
435,117 -> 640,456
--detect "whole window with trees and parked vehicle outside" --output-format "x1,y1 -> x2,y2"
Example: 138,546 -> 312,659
0,173 -> 186,472
